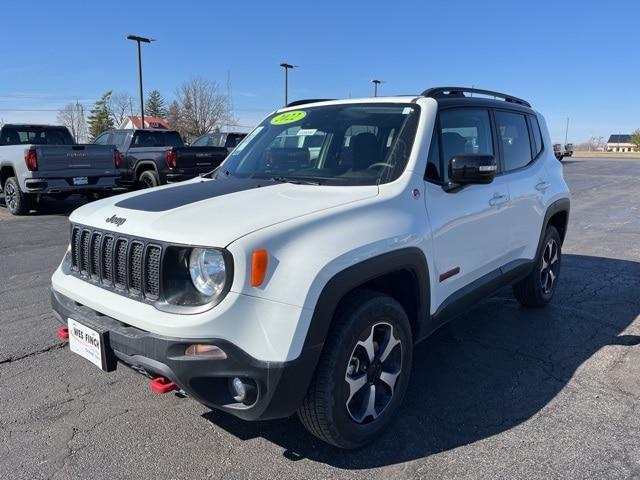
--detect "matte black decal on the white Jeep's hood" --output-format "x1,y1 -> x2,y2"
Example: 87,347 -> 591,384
116,177 -> 278,212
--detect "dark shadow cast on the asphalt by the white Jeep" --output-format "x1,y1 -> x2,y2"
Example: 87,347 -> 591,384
204,255 -> 640,469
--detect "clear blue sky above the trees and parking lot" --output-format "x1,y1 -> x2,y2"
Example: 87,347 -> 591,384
0,0 -> 640,142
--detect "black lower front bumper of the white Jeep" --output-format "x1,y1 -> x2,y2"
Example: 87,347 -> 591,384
51,289 -> 321,420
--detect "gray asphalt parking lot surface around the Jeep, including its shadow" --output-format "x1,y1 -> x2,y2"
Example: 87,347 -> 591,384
0,158 -> 640,480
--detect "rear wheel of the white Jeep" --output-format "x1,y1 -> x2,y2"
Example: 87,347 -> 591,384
513,225 -> 562,307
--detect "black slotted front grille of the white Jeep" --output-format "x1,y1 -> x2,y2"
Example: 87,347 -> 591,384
71,226 -> 162,301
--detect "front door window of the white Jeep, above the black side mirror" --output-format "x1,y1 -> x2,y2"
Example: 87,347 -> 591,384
440,108 -> 494,180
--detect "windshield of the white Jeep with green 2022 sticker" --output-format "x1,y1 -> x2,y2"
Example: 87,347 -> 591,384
217,103 -> 420,185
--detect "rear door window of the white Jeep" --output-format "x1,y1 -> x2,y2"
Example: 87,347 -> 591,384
495,111 -> 532,172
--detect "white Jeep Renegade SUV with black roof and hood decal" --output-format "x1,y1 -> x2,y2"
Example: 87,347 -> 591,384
52,87 -> 569,448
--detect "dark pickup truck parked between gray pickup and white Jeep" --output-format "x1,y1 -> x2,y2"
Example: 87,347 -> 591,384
94,129 -> 227,188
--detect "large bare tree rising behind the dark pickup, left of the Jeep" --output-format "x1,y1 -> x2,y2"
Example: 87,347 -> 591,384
174,77 -> 235,141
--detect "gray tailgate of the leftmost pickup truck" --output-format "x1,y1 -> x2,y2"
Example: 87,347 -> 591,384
31,145 -> 115,175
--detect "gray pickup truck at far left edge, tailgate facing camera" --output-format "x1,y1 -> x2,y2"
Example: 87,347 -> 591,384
0,124 -> 120,215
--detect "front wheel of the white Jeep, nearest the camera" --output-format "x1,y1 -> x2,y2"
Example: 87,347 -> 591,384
298,290 -> 413,448
